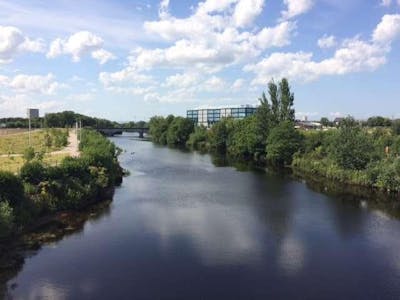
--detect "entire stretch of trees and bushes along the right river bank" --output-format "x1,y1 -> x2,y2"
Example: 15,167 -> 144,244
149,79 -> 400,192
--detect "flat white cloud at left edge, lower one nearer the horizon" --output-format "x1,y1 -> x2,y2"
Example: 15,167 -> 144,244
0,73 -> 65,95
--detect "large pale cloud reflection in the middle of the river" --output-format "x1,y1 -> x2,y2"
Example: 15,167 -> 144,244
138,203 -> 262,265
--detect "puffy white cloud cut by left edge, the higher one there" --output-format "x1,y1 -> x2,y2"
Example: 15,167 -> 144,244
0,26 -> 44,64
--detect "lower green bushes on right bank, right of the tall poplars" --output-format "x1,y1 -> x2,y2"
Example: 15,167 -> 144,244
293,117 -> 400,193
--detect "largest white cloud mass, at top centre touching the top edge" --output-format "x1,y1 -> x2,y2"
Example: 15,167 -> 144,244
141,0 -> 295,72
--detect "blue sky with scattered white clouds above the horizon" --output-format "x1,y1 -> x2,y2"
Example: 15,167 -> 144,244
0,0 -> 400,121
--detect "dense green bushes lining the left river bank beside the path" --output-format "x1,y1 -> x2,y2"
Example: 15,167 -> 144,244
0,130 -> 122,237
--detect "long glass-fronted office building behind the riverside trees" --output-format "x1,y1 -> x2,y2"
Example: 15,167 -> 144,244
186,105 -> 257,127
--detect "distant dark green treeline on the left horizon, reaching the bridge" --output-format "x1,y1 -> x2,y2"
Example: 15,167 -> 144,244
0,111 -> 147,128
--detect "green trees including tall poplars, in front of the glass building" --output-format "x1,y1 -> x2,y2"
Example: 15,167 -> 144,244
149,79 -> 303,165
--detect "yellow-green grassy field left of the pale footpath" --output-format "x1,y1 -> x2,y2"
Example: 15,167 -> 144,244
0,130 -> 67,155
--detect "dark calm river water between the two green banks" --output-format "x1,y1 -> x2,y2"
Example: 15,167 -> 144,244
8,137 -> 400,299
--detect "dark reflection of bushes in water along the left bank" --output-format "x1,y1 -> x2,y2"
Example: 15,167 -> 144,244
0,201 -> 111,299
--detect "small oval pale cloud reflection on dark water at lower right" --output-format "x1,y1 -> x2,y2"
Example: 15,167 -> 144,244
278,236 -> 305,275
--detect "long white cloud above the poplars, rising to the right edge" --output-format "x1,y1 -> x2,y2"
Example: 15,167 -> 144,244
244,15 -> 400,85
